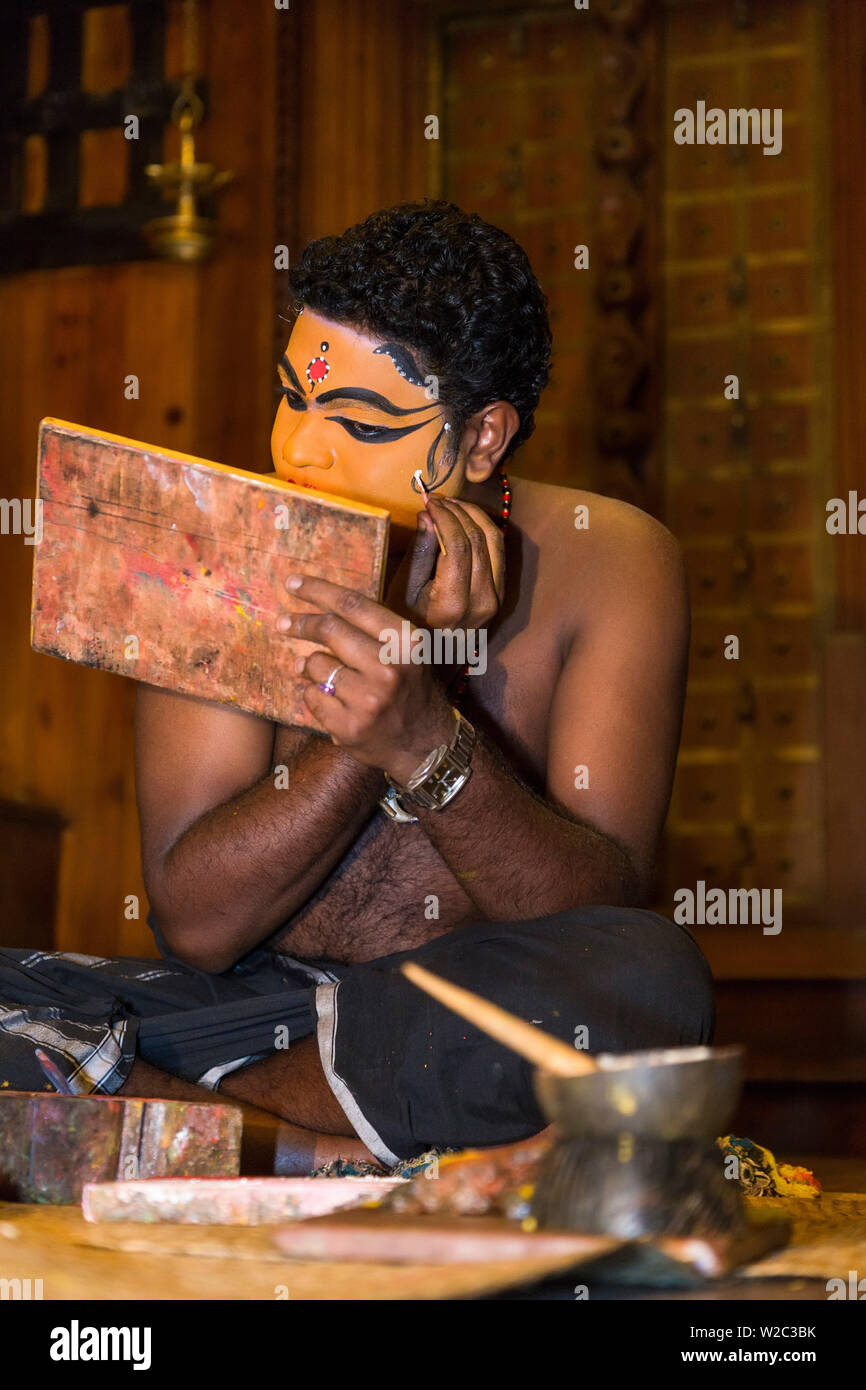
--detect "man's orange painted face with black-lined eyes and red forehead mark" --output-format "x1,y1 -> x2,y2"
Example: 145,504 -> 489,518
271,309 -> 463,535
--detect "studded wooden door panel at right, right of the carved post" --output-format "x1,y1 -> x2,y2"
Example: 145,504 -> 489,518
664,0 -> 831,928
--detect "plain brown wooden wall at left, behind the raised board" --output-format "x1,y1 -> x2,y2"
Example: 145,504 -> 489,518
0,0 -> 278,954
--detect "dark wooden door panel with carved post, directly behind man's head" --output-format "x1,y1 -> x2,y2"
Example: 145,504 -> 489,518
431,0 -> 659,510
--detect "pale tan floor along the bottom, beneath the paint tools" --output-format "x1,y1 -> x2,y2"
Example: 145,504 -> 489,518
0,1158 -> 866,1301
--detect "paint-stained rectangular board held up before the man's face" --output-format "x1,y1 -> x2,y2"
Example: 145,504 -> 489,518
31,418 -> 389,726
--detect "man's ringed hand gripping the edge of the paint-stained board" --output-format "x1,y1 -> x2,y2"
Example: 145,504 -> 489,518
283,575 -> 455,783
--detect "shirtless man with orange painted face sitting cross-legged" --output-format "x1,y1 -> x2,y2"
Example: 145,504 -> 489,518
0,202 -> 713,1172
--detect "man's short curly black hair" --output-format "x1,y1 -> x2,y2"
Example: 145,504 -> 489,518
288,197 -> 552,460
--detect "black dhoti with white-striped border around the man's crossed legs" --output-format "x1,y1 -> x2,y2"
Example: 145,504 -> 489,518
0,906 -> 714,1165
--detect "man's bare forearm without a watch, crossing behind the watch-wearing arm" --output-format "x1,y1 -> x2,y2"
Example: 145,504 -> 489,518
147,738 -> 384,972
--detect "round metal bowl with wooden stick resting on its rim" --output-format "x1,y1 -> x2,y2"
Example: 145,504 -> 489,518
534,1047 -> 744,1140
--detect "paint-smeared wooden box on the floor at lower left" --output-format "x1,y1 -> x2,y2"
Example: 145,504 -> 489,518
0,1091 -> 243,1204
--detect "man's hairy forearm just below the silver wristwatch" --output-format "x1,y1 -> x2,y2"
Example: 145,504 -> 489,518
403,735 -> 641,922
